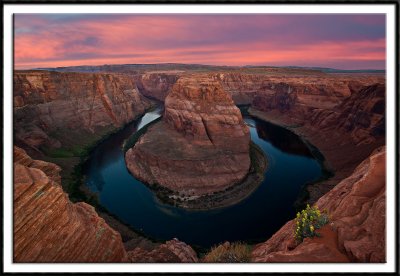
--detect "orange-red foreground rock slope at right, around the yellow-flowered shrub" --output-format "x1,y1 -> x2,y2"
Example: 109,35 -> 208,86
252,147 -> 386,262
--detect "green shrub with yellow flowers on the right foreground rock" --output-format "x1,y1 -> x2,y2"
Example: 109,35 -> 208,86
294,204 -> 329,242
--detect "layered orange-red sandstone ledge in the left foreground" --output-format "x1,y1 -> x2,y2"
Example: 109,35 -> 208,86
13,147 -> 197,262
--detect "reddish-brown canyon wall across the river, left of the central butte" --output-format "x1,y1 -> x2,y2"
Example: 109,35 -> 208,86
14,71 -> 150,153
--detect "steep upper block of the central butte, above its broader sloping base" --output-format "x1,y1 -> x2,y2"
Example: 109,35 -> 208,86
164,75 -> 249,150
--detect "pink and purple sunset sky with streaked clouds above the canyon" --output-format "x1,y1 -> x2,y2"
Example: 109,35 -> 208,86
14,14 -> 386,69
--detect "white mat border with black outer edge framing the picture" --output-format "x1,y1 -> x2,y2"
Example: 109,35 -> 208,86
3,4 -> 397,272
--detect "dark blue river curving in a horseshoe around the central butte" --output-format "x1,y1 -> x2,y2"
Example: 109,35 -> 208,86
84,105 -> 323,247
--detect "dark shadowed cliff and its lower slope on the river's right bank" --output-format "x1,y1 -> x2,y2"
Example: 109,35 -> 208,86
250,83 -> 386,203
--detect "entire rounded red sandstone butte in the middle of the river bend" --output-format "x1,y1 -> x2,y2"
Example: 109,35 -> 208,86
126,75 -> 250,196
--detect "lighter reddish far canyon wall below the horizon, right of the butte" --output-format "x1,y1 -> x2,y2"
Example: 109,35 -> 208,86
215,71 -> 384,105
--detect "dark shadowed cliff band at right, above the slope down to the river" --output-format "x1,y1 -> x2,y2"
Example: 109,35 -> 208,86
253,83 -> 386,144
